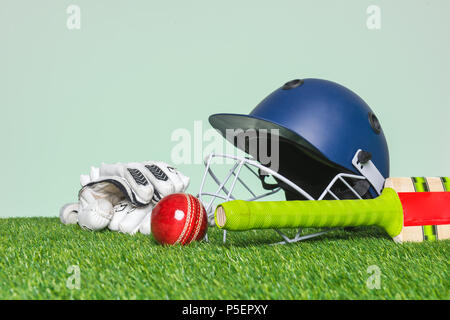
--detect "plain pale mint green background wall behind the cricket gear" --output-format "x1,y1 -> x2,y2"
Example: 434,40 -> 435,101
0,0 -> 450,217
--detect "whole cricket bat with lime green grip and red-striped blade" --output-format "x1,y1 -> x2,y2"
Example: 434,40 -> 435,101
215,177 -> 450,242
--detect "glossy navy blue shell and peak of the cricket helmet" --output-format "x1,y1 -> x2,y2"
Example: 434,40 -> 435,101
209,79 -> 389,178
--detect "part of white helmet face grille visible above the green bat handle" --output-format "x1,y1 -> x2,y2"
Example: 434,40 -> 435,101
198,154 -> 371,224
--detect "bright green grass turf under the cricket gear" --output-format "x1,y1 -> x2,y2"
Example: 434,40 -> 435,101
0,218 -> 450,299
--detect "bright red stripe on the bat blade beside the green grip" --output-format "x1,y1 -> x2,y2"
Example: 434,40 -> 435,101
398,192 -> 450,227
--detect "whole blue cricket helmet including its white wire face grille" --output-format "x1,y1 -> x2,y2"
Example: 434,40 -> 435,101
199,79 -> 389,239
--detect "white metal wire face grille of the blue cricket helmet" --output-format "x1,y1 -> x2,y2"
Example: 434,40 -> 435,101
197,153 -> 368,244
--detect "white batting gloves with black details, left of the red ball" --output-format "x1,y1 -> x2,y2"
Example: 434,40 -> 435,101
60,161 -> 189,234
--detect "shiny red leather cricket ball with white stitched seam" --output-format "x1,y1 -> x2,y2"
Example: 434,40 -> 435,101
152,193 -> 208,245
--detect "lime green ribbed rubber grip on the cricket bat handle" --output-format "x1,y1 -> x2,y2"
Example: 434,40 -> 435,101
215,188 -> 403,237
